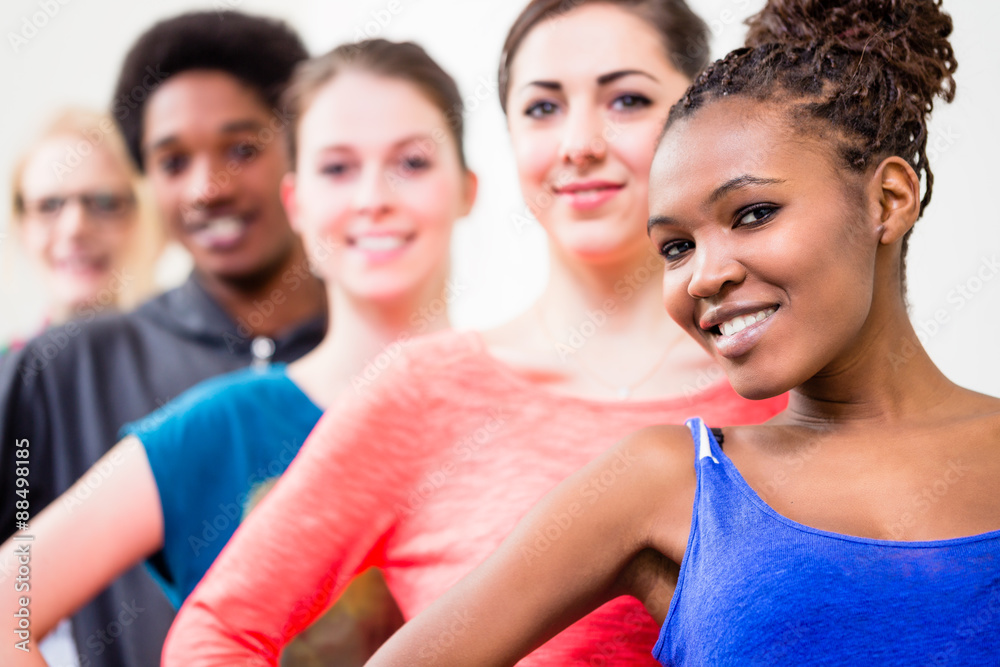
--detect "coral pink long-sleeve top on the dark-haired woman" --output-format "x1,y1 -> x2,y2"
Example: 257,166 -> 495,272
163,332 -> 787,667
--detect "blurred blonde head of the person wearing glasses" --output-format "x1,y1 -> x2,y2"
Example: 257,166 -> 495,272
0,109 -> 164,354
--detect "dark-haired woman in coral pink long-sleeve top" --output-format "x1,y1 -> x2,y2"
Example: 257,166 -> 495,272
164,0 -> 785,666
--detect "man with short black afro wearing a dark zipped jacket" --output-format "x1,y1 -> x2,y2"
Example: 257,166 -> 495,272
0,12 -> 326,667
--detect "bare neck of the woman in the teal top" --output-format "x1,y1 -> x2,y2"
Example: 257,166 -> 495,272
288,271 -> 451,408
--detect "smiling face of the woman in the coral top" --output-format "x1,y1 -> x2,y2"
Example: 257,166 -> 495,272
507,3 -> 690,262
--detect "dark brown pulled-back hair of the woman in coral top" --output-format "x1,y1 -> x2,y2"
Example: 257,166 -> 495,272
498,0 -> 709,113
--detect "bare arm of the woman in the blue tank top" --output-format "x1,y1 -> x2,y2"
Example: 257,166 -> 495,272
368,427 -> 694,667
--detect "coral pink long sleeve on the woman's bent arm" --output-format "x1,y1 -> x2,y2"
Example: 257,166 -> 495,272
163,357 -> 431,667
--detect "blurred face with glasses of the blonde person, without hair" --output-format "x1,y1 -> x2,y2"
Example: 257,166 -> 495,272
20,135 -> 137,308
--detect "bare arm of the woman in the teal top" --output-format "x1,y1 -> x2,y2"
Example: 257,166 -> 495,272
0,436 -> 163,667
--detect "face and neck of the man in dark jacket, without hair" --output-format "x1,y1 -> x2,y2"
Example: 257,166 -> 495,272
141,70 -> 323,336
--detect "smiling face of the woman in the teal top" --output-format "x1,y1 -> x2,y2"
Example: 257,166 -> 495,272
285,70 -> 475,299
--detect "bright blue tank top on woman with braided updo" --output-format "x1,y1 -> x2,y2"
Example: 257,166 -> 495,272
653,419 -> 1000,667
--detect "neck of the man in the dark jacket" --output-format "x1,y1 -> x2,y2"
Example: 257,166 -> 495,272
196,241 -> 325,338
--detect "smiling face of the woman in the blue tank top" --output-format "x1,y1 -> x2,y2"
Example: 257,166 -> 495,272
650,99 -> 879,398
